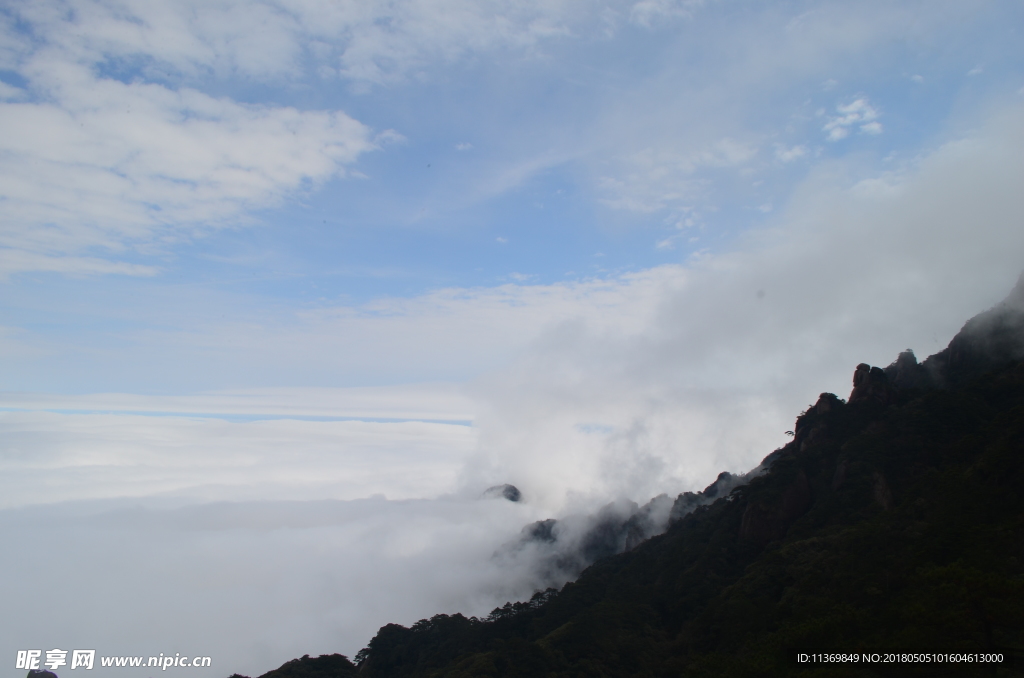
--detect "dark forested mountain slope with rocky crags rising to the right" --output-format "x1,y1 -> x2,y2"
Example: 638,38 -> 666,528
232,284 -> 1024,678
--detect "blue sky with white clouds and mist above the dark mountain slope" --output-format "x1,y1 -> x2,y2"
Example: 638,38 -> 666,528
0,0 -> 1024,678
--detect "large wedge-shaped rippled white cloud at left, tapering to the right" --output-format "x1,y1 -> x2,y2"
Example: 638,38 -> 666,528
0,62 -> 374,272
